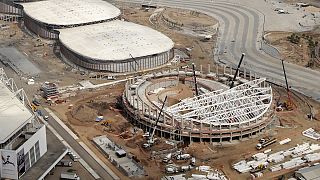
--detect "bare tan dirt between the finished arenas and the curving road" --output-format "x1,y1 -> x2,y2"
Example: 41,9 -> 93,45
117,3 -> 218,71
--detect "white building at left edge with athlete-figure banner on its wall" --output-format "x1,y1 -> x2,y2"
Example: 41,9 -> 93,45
0,68 -> 47,179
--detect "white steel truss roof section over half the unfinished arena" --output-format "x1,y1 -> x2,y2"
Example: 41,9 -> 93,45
166,79 -> 272,125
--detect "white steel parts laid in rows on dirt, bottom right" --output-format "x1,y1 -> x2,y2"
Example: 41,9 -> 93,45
233,143 -> 320,176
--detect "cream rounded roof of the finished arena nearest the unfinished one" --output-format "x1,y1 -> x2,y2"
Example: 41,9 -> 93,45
59,20 -> 174,60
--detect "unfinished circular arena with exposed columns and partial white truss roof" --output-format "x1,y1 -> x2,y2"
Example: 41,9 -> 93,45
122,67 -> 272,142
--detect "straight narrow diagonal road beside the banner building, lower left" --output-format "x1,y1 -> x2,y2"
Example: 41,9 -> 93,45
43,111 -> 113,180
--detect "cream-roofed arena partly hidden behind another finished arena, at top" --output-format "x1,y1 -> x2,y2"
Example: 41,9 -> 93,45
21,0 -> 121,39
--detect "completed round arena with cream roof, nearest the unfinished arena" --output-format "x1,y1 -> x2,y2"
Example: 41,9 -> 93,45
59,20 -> 174,73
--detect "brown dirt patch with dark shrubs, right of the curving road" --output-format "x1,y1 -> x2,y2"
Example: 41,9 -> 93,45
266,29 -> 320,71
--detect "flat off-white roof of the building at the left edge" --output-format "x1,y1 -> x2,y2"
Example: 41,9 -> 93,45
0,81 -> 33,144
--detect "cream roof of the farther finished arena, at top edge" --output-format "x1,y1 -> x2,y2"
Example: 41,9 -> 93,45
22,0 -> 121,25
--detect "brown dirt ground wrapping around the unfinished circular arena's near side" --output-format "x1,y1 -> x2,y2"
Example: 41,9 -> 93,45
47,78 -> 320,179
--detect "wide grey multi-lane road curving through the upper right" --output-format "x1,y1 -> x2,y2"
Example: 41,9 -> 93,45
122,0 -> 320,101
